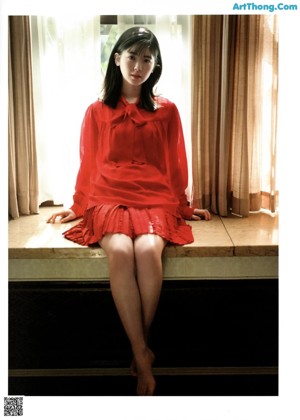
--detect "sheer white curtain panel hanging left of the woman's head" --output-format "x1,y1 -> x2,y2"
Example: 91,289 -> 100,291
31,16 -> 100,206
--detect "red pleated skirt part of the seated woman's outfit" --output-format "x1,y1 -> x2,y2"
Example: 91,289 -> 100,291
63,204 -> 194,246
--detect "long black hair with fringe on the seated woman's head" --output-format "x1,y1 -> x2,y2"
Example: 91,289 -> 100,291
103,26 -> 162,111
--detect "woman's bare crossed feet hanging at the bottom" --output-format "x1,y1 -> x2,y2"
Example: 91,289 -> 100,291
134,349 -> 156,396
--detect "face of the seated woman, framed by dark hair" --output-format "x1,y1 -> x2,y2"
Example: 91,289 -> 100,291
115,45 -> 155,86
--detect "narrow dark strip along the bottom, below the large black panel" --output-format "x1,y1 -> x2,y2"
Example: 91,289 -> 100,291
9,375 -> 278,396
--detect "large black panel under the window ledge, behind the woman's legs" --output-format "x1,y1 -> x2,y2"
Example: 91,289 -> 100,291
9,280 -> 278,394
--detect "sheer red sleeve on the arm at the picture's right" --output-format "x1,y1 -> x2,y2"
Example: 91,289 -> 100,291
168,105 -> 194,219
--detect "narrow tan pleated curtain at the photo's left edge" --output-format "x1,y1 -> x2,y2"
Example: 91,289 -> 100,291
8,16 -> 38,219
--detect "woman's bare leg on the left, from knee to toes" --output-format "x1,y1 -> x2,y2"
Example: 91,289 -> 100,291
100,234 -> 155,395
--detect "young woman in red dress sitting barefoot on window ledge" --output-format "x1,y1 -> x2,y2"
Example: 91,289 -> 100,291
48,27 -> 210,395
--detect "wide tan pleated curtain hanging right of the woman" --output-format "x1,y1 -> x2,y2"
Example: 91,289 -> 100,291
192,15 -> 278,216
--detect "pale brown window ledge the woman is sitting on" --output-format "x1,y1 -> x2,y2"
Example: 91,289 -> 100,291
8,208 -> 278,280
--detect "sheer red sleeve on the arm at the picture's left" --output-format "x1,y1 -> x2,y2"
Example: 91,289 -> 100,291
71,105 -> 98,217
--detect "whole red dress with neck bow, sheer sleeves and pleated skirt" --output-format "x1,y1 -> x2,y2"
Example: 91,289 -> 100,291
64,97 -> 194,245
